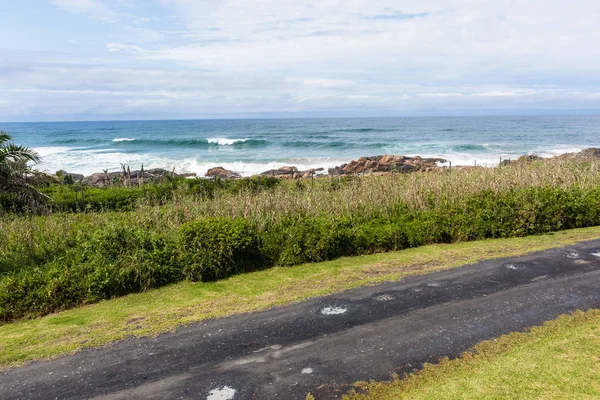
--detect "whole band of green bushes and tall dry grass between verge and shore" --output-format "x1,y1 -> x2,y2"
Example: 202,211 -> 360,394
0,159 -> 600,322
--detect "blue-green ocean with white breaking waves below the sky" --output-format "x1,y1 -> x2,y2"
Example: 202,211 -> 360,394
0,116 -> 600,175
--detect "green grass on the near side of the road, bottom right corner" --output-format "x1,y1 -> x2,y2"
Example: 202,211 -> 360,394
345,310 -> 600,400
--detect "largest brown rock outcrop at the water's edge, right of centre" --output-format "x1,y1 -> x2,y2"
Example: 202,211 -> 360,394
329,154 -> 447,175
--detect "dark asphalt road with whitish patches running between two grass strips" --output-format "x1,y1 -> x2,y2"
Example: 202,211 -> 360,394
0,240 -> 600,400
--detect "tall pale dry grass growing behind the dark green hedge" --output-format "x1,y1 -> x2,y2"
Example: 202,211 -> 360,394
137,160 -> 600,226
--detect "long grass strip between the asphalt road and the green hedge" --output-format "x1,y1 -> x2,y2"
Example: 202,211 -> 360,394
0,227 -> 600,368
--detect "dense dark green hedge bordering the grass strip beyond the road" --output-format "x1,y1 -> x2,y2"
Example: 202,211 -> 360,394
0,188 -> 600,321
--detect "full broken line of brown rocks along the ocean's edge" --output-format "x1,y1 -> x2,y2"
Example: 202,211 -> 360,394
55,148 -> 600,187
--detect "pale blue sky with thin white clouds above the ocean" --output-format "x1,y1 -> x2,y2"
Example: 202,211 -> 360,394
0,0 -> 600,121
